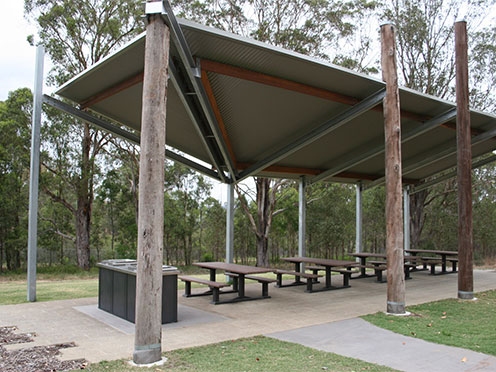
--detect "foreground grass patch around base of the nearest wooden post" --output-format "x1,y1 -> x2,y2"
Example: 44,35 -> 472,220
74,336 -> 395,372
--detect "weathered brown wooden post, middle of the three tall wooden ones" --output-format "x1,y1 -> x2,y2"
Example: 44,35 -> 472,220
381,24 -> 405,314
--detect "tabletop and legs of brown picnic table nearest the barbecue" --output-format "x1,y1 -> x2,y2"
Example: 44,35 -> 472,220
193,262 -> 274,304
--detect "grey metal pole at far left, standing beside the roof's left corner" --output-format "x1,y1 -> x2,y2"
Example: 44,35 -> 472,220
28,45 -> 45,302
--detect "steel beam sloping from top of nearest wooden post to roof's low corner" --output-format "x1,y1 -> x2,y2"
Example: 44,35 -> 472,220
149,0 -> 237,182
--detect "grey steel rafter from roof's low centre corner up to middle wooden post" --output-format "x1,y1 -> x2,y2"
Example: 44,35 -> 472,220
239,89 -> 386,180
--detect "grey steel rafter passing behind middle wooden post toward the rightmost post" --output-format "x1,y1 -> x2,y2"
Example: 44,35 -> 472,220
310,108 -> 456,183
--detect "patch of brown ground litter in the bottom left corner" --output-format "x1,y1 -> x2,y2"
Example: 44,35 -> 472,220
0,327 -> 87,372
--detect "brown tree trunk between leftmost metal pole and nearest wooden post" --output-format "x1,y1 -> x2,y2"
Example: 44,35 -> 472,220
76,123 -> 93,270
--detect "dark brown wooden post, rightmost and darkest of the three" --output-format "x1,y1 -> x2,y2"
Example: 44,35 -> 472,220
455,21 -> 474,299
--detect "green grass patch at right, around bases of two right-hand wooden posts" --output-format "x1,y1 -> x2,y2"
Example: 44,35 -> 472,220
362,290 -> 496,355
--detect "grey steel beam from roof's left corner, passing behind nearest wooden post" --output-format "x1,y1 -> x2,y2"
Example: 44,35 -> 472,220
43,94 -> 220,180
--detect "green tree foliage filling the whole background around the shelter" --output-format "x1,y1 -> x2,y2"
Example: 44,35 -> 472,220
0,0 -> 496,270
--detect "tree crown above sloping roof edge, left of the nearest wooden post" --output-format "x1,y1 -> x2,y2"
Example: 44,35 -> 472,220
24,0 -> 143,84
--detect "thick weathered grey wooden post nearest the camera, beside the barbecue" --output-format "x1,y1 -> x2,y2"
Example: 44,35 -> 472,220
133,10 -> 170,364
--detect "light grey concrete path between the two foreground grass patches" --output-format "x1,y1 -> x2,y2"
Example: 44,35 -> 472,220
266,318 -> 496,372
